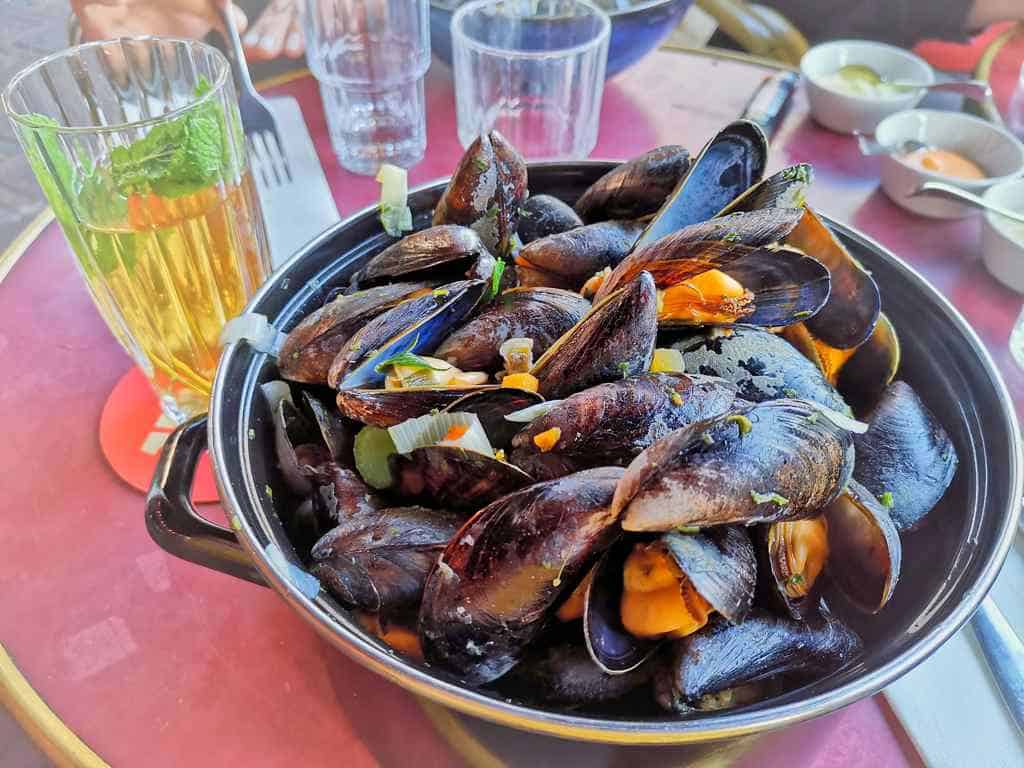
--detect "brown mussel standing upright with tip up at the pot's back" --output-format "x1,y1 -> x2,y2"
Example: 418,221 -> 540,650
433,130 -> 526,257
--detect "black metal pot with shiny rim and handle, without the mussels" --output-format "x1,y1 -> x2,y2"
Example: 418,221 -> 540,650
146,161 -> 1022,743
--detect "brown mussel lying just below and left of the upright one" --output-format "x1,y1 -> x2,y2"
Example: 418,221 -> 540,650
353,224 -> 495,287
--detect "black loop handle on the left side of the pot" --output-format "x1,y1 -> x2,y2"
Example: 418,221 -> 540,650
145,414 -> 267,587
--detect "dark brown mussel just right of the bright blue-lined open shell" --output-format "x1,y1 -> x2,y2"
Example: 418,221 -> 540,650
434,288 -> 590,372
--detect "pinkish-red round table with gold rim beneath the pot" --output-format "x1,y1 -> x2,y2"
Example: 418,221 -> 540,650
0,51 -> 1024,768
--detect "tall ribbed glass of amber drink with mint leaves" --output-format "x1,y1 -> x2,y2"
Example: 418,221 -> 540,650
0,37 -> 269,421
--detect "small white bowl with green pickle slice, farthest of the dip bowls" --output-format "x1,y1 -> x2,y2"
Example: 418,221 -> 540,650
800,40 -> 935,133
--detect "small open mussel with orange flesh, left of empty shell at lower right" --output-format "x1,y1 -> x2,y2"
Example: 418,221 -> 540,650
760,514 -> 827,621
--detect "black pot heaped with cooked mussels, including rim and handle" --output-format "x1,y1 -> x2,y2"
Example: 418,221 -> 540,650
146,121 -> 1022,743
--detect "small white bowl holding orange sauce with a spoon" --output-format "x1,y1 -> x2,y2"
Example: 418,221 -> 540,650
874,110 -> 1024,219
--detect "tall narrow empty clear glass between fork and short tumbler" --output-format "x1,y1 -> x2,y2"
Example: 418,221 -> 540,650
304,0 -> 430,174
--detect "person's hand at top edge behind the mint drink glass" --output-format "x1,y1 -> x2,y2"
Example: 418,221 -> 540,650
71,0 -> 248,40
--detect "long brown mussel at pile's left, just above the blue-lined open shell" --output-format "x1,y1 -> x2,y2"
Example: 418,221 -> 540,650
278,283 -> 430,384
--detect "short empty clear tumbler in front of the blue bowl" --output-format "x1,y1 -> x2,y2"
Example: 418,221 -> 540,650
452,0 -> 611,160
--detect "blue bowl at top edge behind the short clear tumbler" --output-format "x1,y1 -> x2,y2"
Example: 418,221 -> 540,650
430,0 -> 693,78
